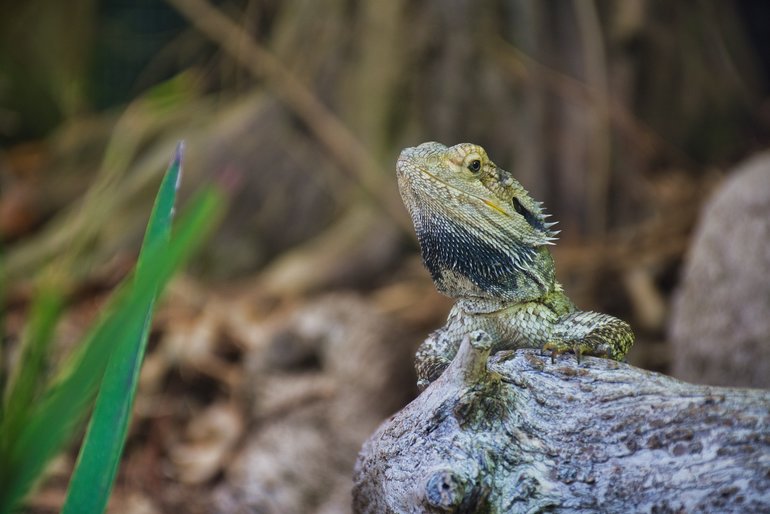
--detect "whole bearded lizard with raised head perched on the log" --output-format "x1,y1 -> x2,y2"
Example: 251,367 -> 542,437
396,142 -> 634,390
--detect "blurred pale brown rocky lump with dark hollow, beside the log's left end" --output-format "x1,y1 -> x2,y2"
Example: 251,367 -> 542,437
210,294 -> 415,514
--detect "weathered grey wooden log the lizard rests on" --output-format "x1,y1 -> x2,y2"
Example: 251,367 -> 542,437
353,332 -> 770,513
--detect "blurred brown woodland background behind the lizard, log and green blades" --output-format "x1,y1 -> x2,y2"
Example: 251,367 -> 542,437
0,0 -> 770,513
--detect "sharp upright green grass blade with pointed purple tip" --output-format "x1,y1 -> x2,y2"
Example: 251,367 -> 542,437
62,143 -> 182,514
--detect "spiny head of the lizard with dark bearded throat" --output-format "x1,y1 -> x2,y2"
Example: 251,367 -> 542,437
397,142 -> 556,301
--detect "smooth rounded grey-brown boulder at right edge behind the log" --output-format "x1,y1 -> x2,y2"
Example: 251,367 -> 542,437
669,153 -> 770,388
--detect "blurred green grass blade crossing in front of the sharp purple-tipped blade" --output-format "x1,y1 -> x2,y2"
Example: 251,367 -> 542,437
0,182 -> 224,513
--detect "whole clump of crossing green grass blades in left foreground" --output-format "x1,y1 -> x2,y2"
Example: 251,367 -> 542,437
0,146 -> 223,513
